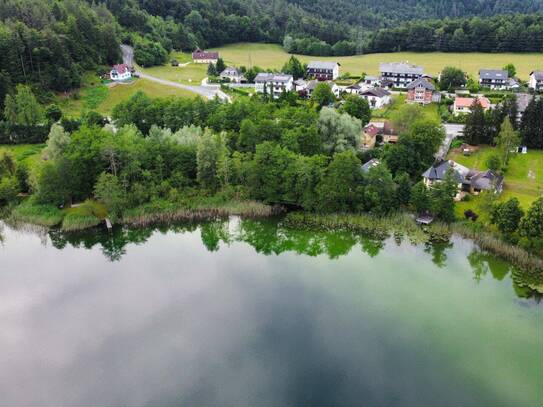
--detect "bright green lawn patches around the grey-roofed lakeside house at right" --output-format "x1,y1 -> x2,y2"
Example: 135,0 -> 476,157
449,147 -> 543,209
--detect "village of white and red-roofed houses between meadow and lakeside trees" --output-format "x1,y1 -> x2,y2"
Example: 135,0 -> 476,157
103,49 -> 543,223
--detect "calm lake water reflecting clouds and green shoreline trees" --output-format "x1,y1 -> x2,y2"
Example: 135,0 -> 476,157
0,219 -> 543,407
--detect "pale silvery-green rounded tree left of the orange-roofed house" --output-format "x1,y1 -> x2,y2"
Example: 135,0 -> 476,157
317,107 -> 362,153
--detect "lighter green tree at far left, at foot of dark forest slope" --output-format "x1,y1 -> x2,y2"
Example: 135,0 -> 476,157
4,85 -> 44,126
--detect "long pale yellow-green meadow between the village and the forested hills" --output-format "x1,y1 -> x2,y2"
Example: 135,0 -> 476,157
213,43 -> 543,80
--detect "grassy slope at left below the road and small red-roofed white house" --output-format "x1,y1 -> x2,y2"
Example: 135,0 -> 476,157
60,79 -> 196,116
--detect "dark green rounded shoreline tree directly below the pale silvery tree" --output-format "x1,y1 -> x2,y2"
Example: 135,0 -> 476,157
317,150 -> 363,212
